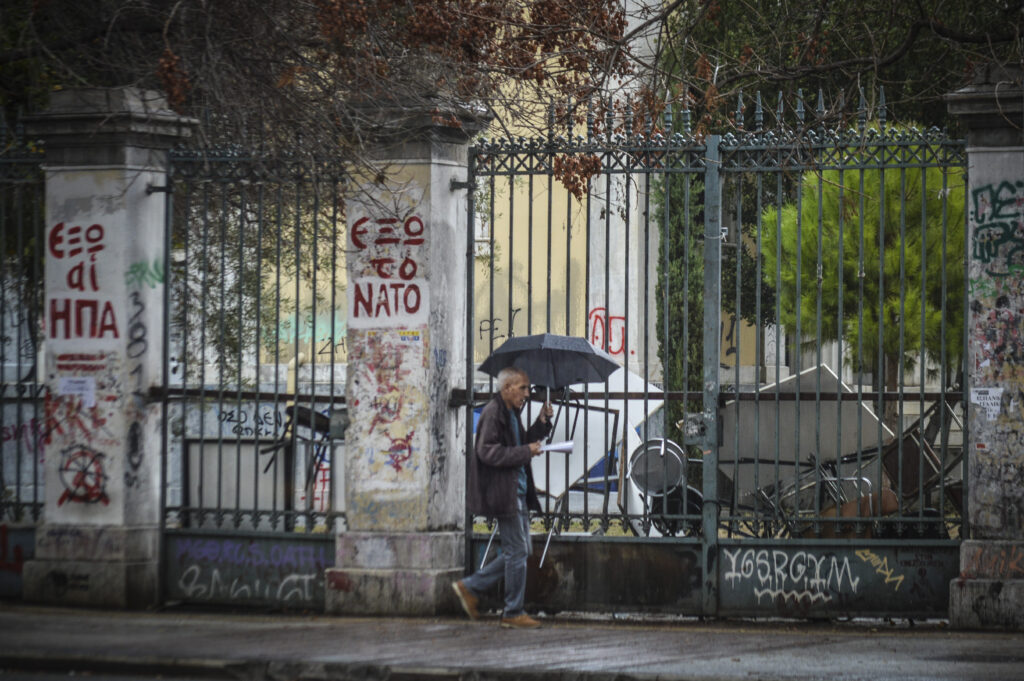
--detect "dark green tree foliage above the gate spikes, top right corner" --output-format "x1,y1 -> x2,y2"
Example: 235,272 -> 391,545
660,0 -> 1024,127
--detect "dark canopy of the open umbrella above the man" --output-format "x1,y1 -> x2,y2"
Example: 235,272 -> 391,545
480,334 -> 618,388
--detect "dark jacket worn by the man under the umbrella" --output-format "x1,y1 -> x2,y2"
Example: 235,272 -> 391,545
466,394 -> 551,517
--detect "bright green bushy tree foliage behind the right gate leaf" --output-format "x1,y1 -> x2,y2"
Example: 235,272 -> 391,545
762,137 -> 965,388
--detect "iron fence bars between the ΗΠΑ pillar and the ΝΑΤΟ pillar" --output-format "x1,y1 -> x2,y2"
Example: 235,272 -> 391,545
166,151 -> 346,533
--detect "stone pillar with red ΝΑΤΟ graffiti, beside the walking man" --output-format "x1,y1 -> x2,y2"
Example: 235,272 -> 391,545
326,115 -> 468,614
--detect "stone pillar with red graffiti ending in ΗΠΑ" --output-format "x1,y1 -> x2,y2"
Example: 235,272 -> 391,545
24,88 -> 190,607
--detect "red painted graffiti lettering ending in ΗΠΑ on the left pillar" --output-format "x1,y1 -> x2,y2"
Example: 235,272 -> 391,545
46,222 -> 121,340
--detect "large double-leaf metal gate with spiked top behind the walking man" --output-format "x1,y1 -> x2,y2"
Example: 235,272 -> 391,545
464,96 -> 966,616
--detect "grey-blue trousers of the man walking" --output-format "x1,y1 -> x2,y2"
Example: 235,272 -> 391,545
462,497 -> 531,618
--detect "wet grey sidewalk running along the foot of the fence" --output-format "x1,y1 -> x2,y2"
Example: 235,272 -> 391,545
0,602 -> 1024,681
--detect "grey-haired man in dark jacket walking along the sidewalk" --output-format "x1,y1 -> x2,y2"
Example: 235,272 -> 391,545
452,368 -> 553,629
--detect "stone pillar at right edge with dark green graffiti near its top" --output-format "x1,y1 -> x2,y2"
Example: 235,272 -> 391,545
947,68 -> 1024,630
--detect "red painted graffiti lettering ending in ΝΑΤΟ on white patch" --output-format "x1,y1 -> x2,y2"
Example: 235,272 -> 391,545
347,215 -> 429,329
